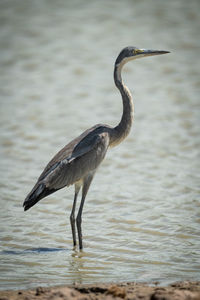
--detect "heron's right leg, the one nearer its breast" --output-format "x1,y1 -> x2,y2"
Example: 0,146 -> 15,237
76,173 -> 94,250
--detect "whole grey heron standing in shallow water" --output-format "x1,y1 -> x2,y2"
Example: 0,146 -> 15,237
23,47 -> 168,249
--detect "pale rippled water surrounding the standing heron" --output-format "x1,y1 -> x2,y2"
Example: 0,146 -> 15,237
0,0 -> 200,289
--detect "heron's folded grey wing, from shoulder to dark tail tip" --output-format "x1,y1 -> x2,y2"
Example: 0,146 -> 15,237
24,126 -> 109,210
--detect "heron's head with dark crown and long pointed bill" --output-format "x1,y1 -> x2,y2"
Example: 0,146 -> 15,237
116,46 -> 170,64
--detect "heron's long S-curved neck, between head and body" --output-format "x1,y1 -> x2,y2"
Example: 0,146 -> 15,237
110,61 -> 134,146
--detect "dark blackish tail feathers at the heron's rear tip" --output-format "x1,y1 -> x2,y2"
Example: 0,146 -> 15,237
23,183 -> 56,210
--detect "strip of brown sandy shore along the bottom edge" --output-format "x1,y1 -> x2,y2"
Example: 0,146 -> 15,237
0,281 -> 200,300
